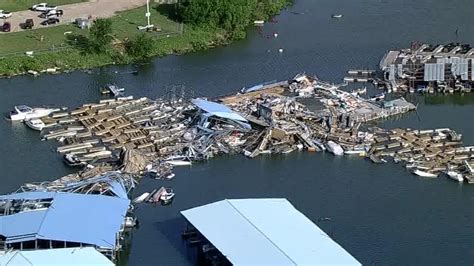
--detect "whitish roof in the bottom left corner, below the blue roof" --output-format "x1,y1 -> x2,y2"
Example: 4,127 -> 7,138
0,247 -> 114,266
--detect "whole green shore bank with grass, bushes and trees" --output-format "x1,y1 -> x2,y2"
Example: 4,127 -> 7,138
0,0 -> 290,76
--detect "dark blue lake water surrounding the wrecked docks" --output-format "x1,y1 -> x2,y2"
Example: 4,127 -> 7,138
0,0 -> 474,265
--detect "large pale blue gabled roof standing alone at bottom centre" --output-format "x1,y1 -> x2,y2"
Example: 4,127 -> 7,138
181,199 -> 360,265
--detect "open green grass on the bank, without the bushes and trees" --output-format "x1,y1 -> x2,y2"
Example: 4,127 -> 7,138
0,1 -> 288,76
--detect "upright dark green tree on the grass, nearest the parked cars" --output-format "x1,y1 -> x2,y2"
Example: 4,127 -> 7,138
89,18 -> 112,53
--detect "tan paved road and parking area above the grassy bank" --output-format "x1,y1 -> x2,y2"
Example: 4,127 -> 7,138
0,0 -> 146,32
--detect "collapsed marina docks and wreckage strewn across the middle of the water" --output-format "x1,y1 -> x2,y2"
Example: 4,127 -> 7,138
7,72 -> 474,185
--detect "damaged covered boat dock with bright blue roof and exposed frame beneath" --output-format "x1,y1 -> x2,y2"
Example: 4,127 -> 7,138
0,192 -> 130,259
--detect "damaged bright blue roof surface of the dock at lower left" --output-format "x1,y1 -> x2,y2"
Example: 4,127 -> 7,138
0,192 -> 130,249
